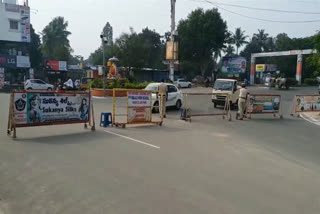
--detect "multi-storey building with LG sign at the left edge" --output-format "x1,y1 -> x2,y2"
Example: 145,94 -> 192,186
0,0 -> 33,87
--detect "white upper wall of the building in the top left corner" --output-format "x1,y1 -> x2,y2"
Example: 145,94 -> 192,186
0,0 -> 29,42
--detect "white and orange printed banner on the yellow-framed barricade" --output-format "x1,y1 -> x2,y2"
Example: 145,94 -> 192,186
127,91 -> 152,123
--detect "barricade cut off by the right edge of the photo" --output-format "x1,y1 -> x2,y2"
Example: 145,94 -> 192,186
291,95 -> 320,117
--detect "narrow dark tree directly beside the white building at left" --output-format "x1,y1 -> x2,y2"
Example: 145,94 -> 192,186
29,25 -> 42,69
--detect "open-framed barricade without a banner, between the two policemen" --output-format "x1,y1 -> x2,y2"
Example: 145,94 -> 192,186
180,93 -> 232,122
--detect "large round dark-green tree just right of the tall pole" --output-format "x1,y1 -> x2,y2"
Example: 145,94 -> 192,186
178,9 -> 229,76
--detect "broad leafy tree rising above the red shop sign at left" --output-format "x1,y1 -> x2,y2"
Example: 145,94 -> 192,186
41,17 -> 72,61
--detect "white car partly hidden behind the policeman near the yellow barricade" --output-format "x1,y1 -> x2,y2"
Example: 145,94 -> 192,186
145,83 -> 183,112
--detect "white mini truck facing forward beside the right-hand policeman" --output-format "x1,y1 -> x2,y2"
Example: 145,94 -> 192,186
212,79 -> 240,108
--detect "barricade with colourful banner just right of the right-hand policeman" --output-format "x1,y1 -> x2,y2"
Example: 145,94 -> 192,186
246,94 -> 283,119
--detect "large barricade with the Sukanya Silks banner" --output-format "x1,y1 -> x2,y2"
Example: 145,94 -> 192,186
7,91 -> 95,138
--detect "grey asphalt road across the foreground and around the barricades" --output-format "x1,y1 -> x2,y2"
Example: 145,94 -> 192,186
0,88 -> 320,214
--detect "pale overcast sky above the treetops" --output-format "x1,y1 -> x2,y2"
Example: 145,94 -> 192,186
25,0 -> 320,58
